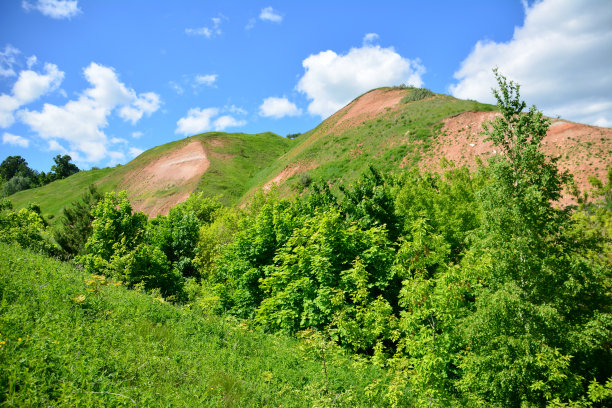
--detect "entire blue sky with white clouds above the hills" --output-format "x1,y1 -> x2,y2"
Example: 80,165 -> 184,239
0,0 -> 612,171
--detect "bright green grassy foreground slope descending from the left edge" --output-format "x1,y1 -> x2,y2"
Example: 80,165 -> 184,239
0,244 -> 388,407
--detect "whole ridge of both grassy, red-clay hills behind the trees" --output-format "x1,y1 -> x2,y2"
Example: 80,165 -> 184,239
11,87 -> 612,217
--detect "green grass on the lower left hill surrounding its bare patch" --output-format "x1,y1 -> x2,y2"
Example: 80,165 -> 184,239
10,133 -> 293,220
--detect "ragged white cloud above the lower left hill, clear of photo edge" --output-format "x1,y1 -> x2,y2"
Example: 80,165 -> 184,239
18,62 -> 161,163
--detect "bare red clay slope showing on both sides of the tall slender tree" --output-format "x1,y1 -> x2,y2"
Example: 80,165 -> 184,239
420,112 -> 612,204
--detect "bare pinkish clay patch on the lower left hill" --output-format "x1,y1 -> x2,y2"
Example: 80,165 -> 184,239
119,140 -> 210,217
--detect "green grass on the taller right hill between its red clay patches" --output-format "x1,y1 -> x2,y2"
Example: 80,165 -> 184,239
241,90 -> 495,200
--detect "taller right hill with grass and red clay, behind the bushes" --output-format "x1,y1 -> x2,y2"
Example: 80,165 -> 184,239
251,88 -> 612,202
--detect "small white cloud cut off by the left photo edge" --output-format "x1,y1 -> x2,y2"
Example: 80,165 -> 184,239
0,64 -> 64,128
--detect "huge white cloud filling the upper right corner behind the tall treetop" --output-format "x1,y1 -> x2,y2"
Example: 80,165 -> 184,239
450,0 -> 612,126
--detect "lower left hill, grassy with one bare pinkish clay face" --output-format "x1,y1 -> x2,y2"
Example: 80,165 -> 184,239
10,132 -> 292,218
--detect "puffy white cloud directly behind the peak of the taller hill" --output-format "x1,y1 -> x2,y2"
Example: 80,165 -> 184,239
297,45 -> 425,118
